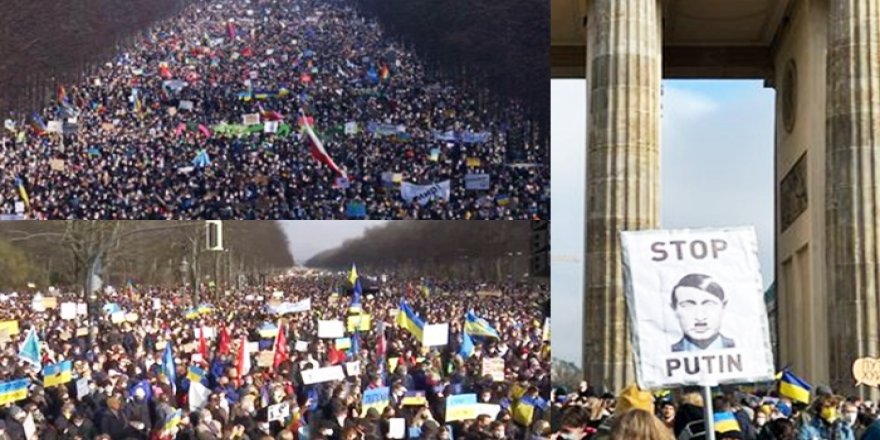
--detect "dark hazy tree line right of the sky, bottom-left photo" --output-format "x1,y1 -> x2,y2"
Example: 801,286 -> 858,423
305,220 -> 531,281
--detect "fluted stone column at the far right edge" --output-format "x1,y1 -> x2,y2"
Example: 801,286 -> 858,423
825,0 -> 880,400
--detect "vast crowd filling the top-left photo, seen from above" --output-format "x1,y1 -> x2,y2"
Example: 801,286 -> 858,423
0,0 -> 550,220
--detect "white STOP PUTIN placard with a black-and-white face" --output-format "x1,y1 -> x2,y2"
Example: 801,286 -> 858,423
620,227 -> 774,389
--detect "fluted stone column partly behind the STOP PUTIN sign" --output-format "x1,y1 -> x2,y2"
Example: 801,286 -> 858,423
583,0 -> 663,392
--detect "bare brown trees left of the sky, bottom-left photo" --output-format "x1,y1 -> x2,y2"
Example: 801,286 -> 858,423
0,221 -> 294,290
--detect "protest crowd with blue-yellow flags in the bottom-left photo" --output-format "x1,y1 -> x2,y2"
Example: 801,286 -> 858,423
0,271 -> 551,440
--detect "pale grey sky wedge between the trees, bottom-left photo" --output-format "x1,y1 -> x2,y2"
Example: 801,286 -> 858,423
281,220 -> 385,264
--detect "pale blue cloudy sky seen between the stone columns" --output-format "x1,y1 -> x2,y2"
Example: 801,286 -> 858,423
550,80 -> 774,364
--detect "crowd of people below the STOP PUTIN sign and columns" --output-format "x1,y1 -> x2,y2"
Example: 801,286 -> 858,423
551,381 -> 880,440
